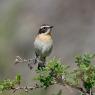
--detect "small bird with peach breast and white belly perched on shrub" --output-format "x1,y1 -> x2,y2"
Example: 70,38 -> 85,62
34,24 -> 53,69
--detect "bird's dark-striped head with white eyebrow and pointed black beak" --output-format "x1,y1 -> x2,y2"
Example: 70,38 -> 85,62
38,24 -> 53,35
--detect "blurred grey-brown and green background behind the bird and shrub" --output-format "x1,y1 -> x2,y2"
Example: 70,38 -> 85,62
0,0 -> 95,95
